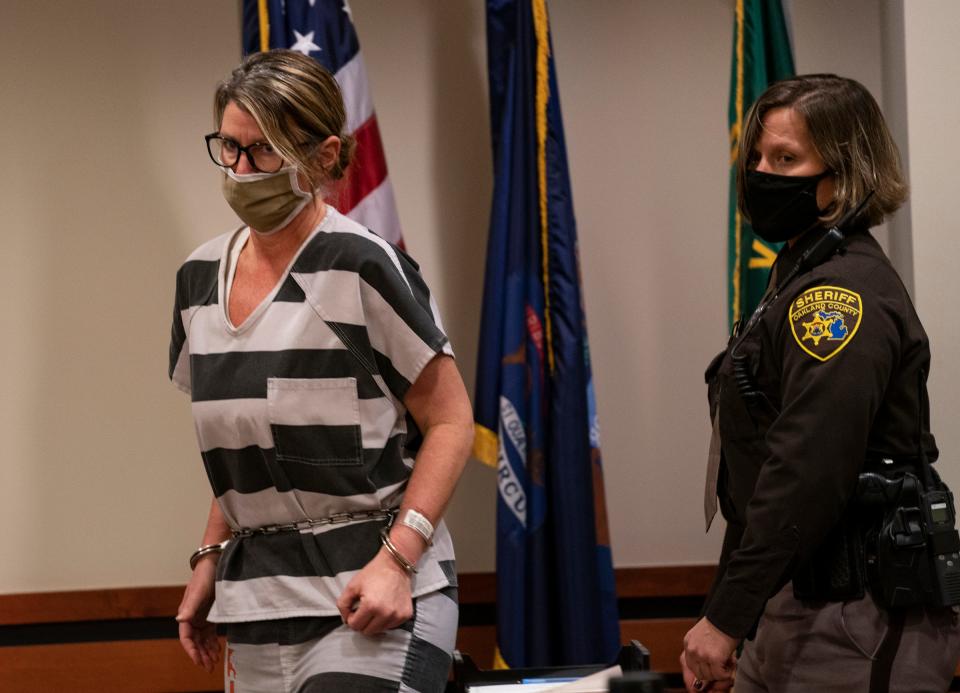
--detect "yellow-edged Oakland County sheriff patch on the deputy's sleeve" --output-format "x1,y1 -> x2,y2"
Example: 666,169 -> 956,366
790,286 -> 863,361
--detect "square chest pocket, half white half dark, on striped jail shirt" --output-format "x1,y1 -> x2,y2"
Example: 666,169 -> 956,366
267,378 -> 363,466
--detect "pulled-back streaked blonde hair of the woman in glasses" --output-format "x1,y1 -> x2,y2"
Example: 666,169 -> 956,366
213,49 -> 355,190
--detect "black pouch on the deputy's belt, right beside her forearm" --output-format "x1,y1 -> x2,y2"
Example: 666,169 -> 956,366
793,511 -> 867,602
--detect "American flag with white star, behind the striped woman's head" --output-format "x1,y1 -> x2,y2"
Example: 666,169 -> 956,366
243,0 -> 403,246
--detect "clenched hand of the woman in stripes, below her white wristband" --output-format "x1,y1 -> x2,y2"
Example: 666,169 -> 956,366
337,549 -> 413,637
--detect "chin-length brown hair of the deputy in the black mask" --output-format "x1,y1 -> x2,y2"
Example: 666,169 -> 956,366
737,74 -> 909,226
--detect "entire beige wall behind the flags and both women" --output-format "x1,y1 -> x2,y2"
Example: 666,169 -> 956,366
0,0 -> 960,592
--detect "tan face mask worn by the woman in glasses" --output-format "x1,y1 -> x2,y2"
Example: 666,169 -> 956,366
223,166 -> 312,235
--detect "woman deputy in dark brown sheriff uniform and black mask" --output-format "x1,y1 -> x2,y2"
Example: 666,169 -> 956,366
681,75 -> 960,693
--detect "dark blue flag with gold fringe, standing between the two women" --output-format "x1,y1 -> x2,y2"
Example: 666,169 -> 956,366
474,0 -> 619,667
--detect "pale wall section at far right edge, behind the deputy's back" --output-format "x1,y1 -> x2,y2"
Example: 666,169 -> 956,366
903,0 -> 960,493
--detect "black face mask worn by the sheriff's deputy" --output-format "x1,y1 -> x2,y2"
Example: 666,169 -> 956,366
744,171 -> 831,243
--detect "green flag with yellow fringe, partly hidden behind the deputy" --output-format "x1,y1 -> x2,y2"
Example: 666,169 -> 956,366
727,0 -> 794,324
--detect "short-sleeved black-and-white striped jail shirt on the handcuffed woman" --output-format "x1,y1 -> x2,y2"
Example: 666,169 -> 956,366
170,207 -> 456,622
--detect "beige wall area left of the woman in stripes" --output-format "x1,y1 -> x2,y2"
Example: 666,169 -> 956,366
0,0 -> 248,592
